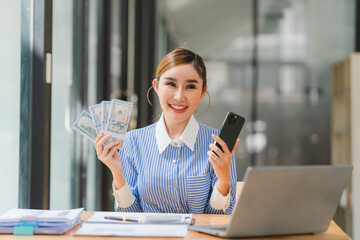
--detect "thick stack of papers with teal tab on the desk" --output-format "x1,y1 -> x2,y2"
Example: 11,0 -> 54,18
0,208 -> 84,234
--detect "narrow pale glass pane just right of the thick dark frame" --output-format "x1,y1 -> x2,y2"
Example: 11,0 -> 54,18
50,0 -> 73,209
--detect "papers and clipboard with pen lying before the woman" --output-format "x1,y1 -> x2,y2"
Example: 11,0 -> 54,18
76,212 -> 193,237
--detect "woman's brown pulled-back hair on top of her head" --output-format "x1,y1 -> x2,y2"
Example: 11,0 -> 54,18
155,48 -> 207,91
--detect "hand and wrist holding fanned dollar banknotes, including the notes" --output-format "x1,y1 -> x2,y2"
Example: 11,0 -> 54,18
73,99 -> 132,190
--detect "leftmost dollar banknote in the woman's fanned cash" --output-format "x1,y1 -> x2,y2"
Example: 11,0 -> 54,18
72,111 -> 97,142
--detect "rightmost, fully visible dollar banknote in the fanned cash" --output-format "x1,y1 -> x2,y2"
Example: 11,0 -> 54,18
105,99 -> 133,146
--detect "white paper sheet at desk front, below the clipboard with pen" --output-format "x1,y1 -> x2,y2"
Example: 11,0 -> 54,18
75,223 -> 188,237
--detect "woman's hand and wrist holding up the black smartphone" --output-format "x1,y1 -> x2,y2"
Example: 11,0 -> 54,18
207,134 -> 240,196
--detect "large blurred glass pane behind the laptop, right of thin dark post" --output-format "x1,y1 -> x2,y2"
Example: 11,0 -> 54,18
257,0 -> 355,168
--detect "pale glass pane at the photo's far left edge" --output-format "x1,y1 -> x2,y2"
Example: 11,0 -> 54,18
0,0 -> 21,214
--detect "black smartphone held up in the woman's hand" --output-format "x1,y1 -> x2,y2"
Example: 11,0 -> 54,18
215,112 -> 245,152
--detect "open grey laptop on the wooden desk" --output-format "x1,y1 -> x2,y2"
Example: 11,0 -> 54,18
190,165 -> 352,238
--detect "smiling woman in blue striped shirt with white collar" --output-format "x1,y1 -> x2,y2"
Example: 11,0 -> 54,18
94,48 -> 239,214
